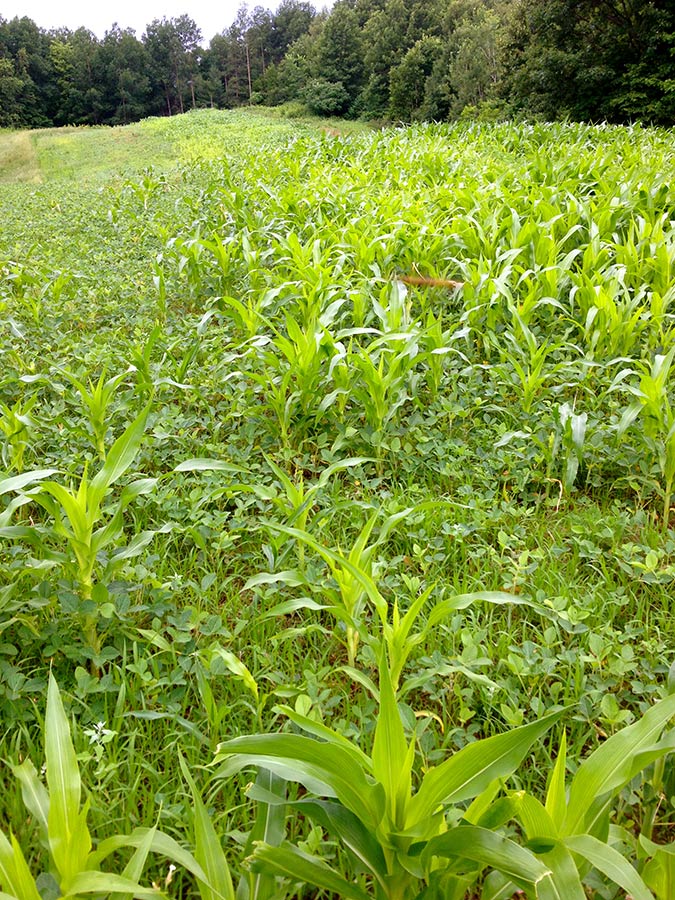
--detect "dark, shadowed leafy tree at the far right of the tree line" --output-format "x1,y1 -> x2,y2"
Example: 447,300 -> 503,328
508,0 -> 674,125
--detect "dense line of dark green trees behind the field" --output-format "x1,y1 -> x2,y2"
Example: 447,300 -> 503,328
0,0 -> 675,128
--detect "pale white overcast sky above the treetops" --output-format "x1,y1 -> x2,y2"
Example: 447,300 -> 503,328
0,0 -> 331,46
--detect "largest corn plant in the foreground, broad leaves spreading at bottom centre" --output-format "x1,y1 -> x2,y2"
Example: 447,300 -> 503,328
215,658 -> 560,900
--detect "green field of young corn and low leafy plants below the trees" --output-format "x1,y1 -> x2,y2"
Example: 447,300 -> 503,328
0,110 -> 675,900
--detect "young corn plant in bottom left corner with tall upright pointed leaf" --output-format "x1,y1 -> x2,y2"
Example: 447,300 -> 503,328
0,675 -> 235,900
